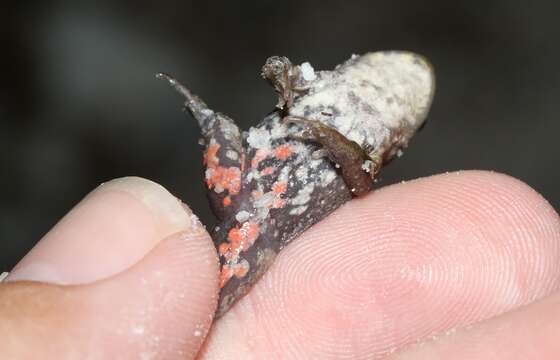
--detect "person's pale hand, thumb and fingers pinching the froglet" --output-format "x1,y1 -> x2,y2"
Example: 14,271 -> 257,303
0,171 -> 560,359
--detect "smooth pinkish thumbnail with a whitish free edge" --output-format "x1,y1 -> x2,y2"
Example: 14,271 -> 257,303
7,177 -> 192,284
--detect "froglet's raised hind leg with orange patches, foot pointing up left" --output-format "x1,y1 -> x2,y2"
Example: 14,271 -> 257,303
157,74 -> 245,220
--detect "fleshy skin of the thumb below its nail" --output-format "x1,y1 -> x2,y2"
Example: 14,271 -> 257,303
0,227 -> 218,359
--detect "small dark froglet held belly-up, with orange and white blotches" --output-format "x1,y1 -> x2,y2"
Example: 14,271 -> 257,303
158,51 -> 435,317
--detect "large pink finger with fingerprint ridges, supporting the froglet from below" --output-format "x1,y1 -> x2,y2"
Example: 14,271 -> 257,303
201,171 -> 560,359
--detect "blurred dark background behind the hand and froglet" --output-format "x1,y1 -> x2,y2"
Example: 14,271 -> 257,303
0,0 -> 560,270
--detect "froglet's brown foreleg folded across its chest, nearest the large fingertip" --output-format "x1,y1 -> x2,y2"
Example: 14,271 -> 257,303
284,116 -> 377,196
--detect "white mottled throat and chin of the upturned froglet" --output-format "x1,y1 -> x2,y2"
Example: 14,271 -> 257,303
289,51 -> 435,159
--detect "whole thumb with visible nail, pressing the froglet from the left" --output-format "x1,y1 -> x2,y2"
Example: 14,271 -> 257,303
0,178 -> 218,359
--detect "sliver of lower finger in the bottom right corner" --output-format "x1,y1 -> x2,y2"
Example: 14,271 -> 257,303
387,293 -> 560,360
